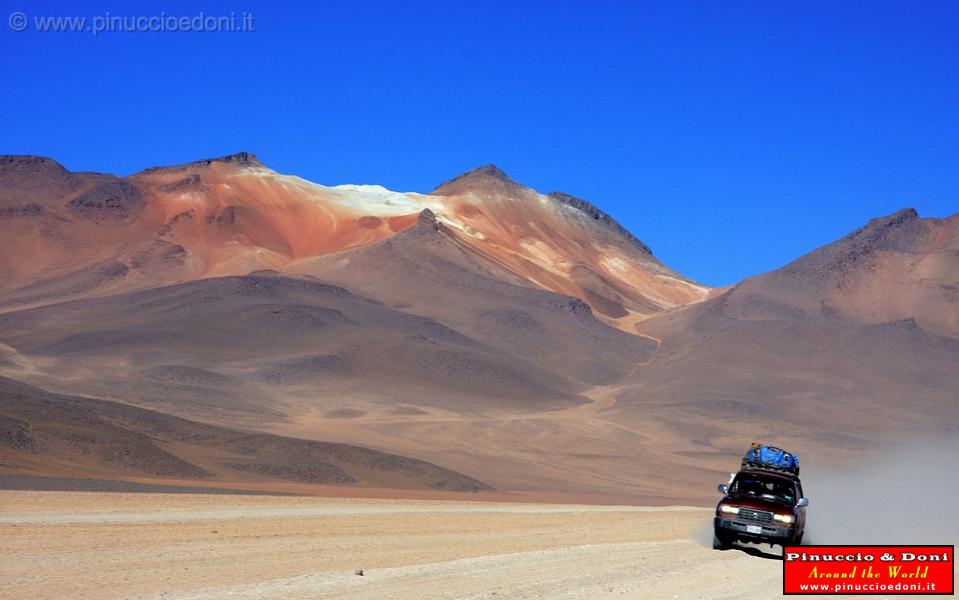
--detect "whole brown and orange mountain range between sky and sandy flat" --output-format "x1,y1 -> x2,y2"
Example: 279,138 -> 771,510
0,153 -> 959,503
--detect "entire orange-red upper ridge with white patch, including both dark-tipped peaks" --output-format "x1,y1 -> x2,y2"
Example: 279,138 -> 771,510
0,152 -> 708,331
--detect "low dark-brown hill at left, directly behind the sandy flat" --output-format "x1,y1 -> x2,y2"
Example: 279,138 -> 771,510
0,377 -> 489,491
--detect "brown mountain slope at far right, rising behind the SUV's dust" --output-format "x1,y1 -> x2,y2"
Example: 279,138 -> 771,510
617,210 -> 959,464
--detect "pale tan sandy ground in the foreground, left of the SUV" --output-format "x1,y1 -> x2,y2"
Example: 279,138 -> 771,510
0,491 -> 848,600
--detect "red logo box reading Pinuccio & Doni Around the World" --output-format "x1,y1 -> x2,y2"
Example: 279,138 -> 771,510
783,546 -> 956,595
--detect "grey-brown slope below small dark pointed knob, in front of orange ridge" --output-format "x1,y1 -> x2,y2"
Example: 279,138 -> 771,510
288,211 -> 656,385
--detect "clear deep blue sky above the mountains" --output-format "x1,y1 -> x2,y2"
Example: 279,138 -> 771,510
0,0 -> 959,284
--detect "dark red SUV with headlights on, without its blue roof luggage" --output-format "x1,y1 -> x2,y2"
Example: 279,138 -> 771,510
713,454 -> 809,549
